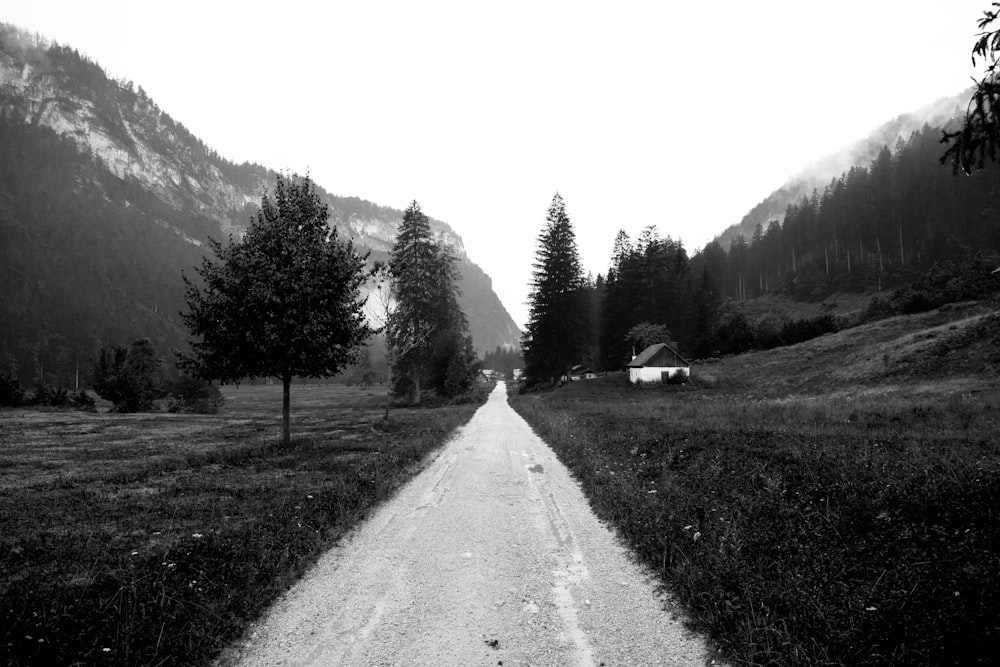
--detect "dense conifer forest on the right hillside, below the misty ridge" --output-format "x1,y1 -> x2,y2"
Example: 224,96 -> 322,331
704,125 -> 1000,301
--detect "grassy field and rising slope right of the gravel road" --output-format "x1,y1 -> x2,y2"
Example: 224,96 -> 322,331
512,303 -> 1000,666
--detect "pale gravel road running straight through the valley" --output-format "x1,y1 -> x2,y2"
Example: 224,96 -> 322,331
222,384 -> 706,667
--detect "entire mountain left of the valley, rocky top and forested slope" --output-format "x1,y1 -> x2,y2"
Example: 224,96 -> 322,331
0,24 -> 520,382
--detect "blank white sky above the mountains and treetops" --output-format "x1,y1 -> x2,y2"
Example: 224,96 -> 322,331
0,0 -> 989,326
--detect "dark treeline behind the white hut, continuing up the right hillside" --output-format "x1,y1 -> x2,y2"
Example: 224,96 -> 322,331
582,120 -> 1000,370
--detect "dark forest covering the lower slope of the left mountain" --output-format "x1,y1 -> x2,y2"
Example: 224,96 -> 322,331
0,118 -> 206,386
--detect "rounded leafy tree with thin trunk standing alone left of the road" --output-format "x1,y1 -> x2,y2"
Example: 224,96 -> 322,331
181,175 -> 372,444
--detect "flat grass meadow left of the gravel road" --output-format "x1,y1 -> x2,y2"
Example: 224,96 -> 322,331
0,385 -> 485,665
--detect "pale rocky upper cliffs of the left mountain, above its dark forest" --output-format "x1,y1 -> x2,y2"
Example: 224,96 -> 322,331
0,24 -> 520,352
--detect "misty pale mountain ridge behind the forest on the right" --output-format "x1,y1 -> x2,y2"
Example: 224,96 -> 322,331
715,88 -> 972,249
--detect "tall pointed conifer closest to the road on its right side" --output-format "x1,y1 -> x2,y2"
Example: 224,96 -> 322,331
521,193 -> 587,383
